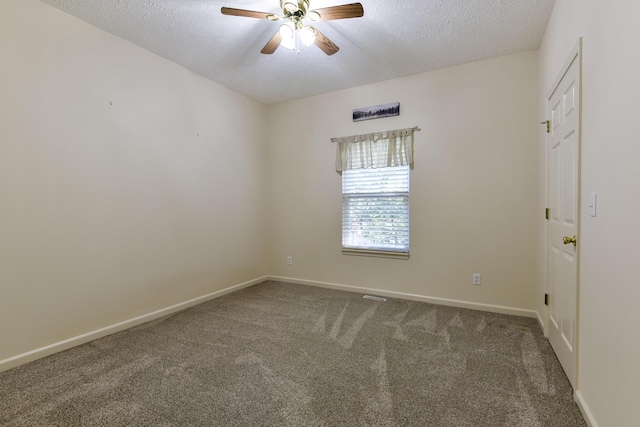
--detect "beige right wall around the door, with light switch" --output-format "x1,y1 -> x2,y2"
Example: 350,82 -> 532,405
538,0 -> 640,427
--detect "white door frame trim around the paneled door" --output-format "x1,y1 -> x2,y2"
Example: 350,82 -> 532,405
544,37 -> 583,392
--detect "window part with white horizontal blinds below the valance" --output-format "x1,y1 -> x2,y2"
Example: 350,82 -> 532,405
342,165 -> 409,258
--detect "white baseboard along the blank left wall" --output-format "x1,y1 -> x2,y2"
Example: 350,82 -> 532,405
0,276 -> 268,372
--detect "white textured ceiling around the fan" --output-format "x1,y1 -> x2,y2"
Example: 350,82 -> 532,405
41,0 -> 555,104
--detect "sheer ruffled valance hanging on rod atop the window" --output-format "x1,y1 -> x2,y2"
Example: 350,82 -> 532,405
332,128 -> 416,173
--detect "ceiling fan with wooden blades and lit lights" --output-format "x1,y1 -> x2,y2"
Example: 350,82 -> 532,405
220,0 -> 364,55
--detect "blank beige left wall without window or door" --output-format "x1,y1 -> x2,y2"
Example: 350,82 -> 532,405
0,0 -> 267,368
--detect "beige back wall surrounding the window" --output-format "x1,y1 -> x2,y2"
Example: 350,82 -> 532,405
268,52 -> 539,313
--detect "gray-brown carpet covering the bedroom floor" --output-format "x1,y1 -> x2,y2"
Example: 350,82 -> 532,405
0,282 -> 586,427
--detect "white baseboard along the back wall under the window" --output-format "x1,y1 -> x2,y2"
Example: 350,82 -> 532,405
268,276 -> 538,318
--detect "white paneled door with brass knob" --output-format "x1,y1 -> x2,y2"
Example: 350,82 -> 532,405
547,45 -> 581,389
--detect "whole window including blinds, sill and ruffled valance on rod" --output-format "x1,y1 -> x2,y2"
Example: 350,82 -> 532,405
332,127 -> 418,259
